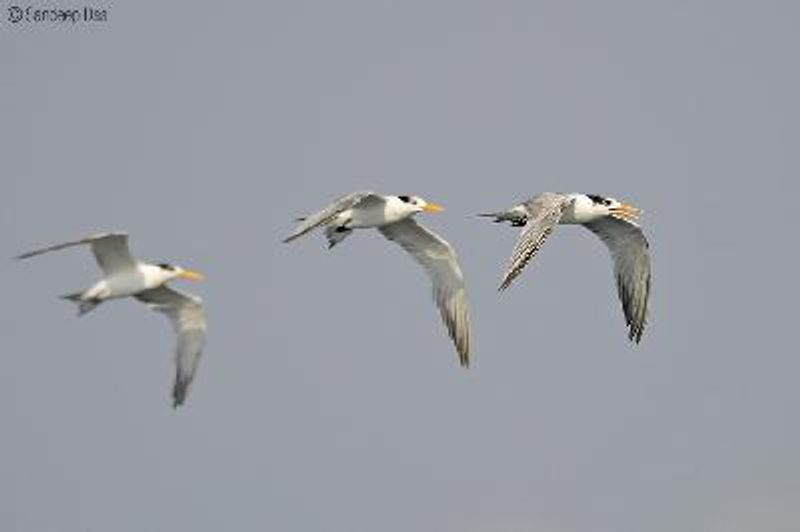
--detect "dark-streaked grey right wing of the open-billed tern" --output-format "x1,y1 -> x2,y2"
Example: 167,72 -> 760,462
585,216 -> 650,343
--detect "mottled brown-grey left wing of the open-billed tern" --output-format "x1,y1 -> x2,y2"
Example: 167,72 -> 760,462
500,192 -> 572,290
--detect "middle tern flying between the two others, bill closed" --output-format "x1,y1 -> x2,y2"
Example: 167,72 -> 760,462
284,192 -> 470,367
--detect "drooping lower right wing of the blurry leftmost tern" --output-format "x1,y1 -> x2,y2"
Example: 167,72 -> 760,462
135,285 -> 206,408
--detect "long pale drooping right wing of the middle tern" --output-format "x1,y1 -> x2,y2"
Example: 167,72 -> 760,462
379,218 -> 470,367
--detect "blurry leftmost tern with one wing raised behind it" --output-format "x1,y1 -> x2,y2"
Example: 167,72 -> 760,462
17,232 -> 206,408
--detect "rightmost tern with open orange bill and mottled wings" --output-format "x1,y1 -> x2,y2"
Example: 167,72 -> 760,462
479,192 -> 650,343
